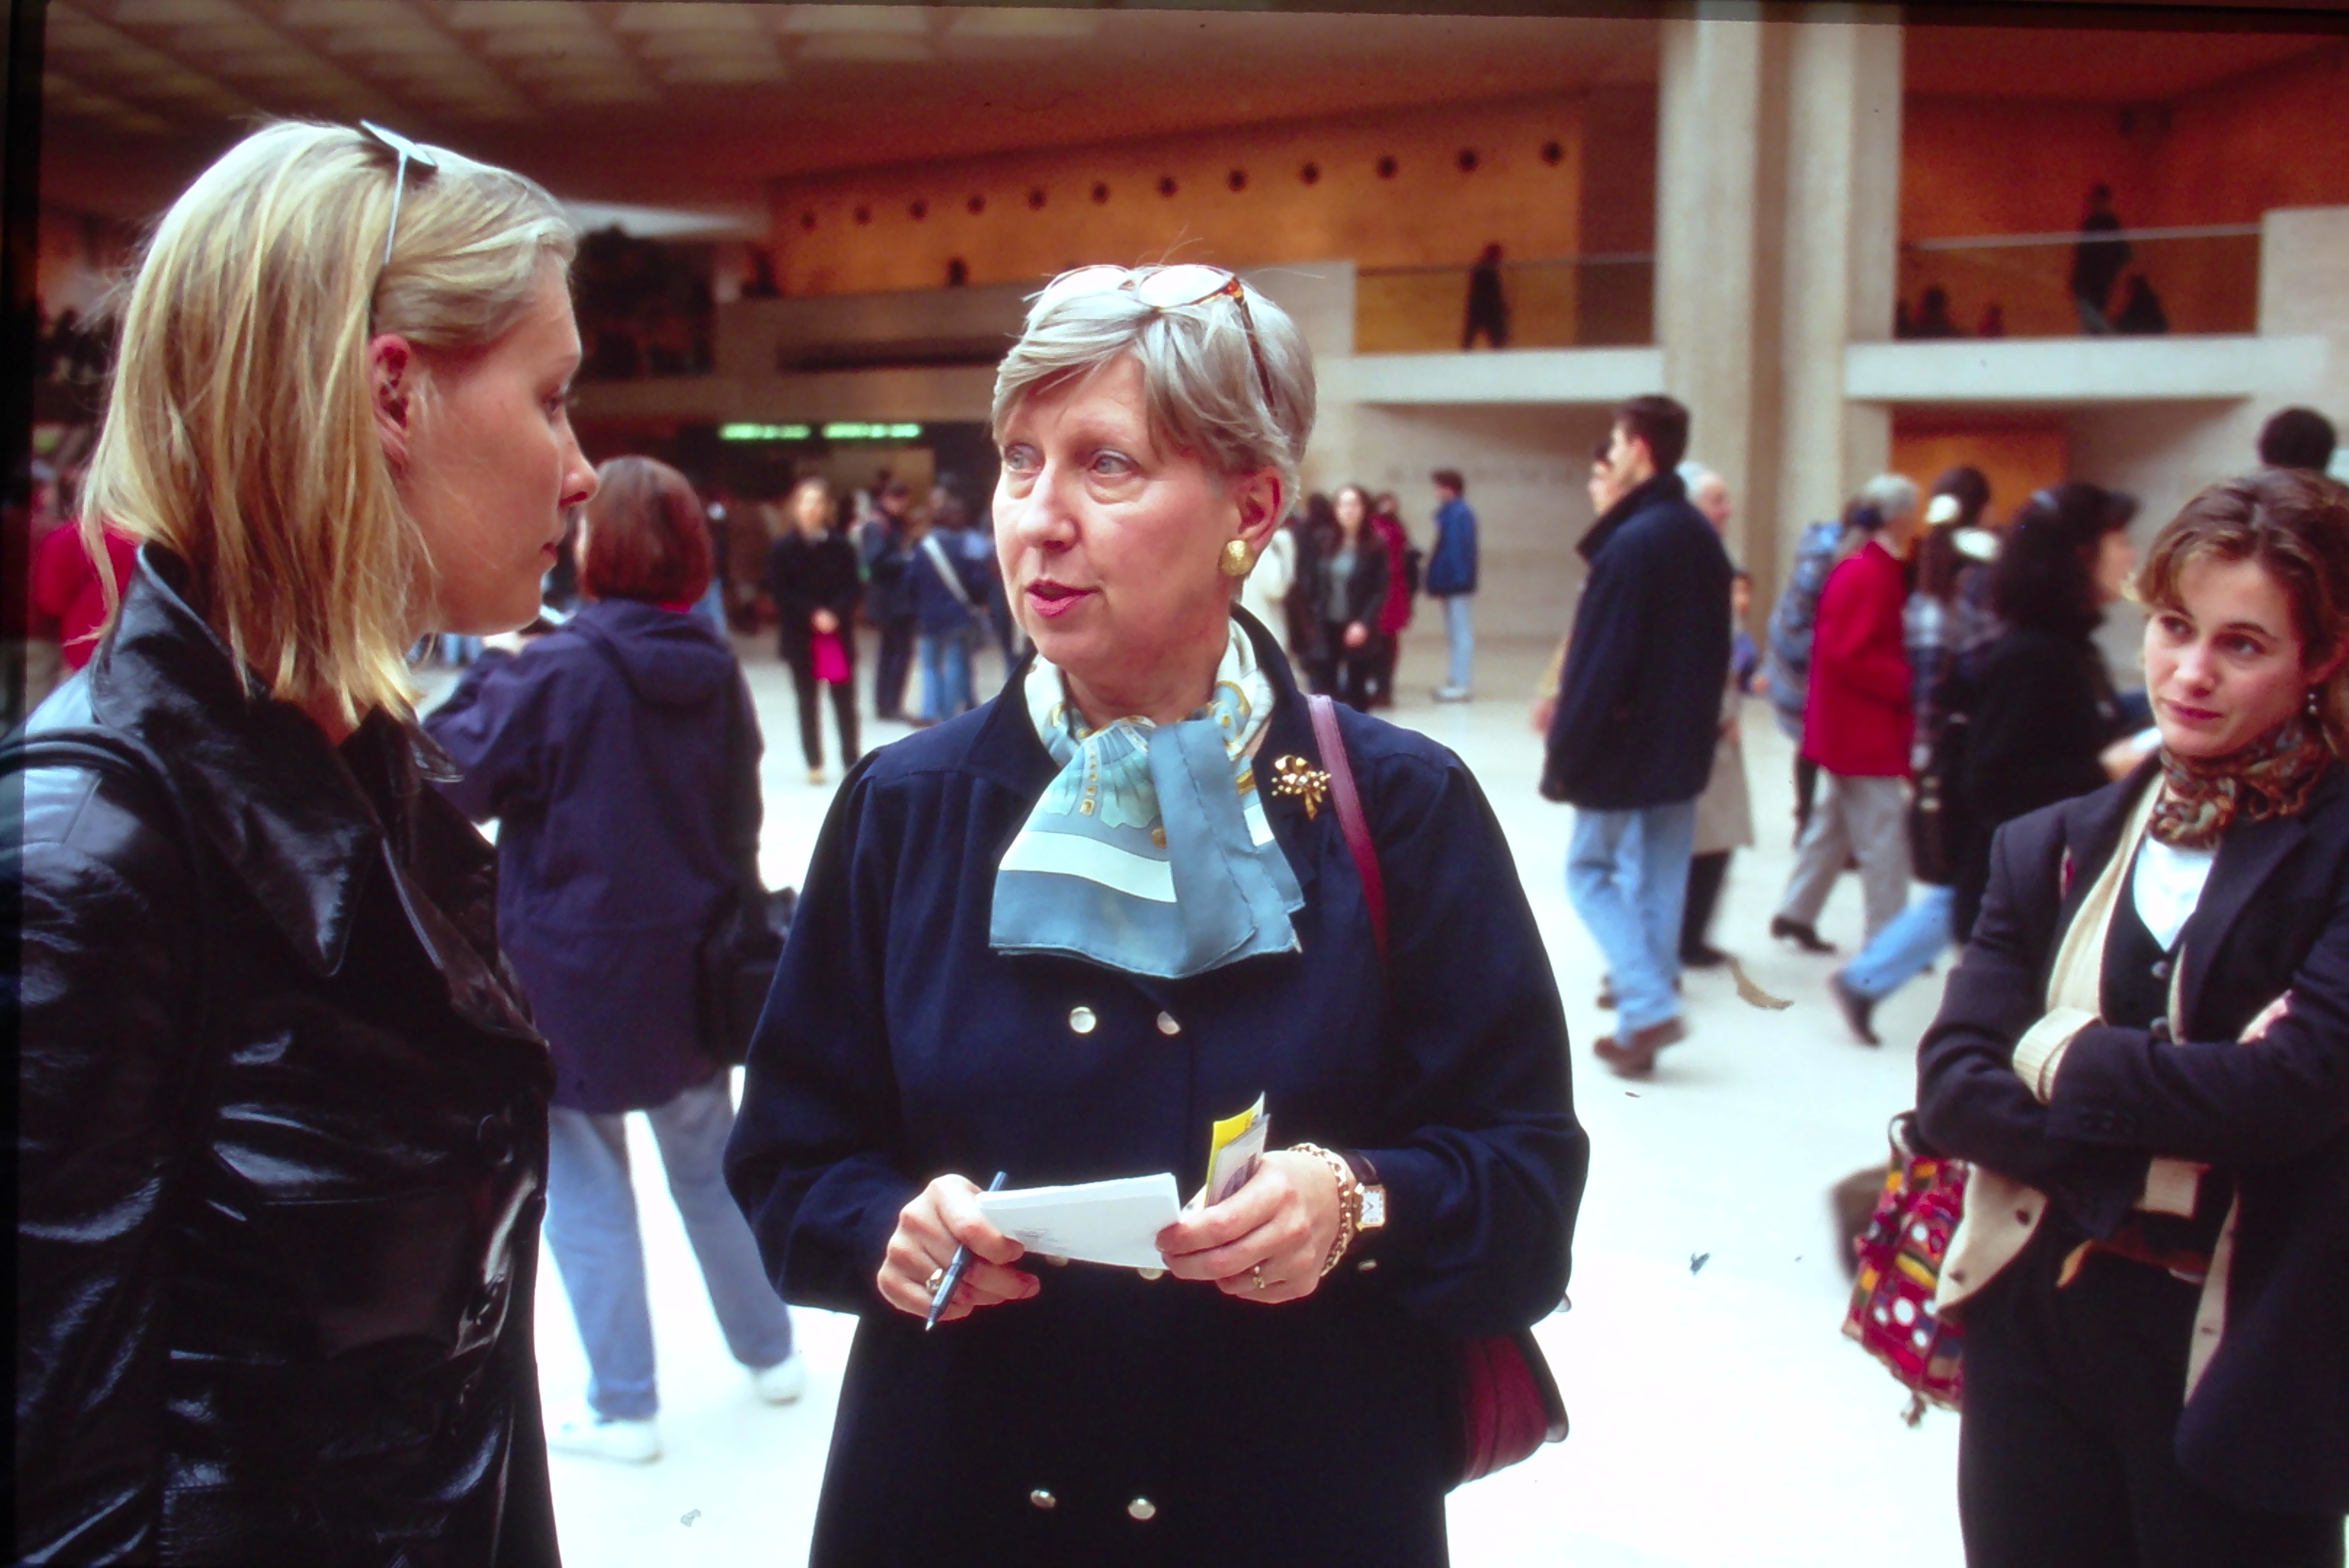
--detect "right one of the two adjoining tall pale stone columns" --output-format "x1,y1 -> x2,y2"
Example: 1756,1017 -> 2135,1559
1771,7 -> 1931,575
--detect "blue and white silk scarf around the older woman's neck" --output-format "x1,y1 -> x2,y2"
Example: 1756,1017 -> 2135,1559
987,622 -> 1306,979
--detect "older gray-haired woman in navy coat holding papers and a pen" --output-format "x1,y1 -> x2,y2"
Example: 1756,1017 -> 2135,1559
728,268 -> 1588,1566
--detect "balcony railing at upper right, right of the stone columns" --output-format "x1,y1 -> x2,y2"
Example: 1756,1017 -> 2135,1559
1893,223 -> 2260,338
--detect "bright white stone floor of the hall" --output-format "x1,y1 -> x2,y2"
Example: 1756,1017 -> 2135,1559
437,638 -> 2180,1568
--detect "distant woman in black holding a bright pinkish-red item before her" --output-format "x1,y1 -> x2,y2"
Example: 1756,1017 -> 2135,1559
766,476 -> 864,784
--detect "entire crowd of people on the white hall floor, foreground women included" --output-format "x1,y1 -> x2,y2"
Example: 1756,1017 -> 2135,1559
0,124 -> 2349,1568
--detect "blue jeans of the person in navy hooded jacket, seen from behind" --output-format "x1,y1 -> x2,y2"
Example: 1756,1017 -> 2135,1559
547,1073 -> 791,1420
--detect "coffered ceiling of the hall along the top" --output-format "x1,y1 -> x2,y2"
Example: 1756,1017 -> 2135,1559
42,0 -> 2337,226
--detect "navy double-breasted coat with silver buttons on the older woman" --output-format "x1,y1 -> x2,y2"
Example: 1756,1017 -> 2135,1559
726,622 -> 1588,1568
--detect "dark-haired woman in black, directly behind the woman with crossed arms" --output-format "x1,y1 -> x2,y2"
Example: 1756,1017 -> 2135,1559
1950,483 -> 2137,941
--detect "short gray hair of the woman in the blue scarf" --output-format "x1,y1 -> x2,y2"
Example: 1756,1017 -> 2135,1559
994,272 -> 1313,505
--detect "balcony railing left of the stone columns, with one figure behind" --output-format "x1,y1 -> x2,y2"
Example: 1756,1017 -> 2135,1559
1353,253 -> 1656,354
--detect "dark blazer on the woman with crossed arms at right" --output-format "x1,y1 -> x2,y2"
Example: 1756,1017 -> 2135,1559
1917,763 -> 2349,1514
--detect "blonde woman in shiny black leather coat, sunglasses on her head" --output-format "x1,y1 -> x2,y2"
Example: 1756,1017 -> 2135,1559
0,124 -> 594,1568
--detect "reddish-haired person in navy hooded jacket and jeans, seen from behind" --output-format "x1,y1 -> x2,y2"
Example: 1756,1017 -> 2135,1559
425,458 -> 806,1462
